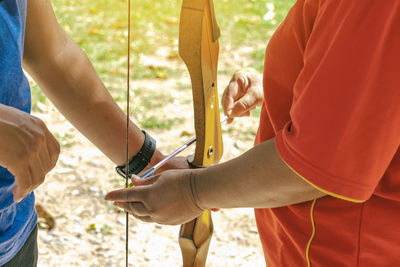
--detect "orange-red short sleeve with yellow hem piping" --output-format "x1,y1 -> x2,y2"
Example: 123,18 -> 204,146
276,1 -> 400,202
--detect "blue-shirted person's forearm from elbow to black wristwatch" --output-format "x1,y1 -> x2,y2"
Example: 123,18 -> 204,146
23,35 -> 153,164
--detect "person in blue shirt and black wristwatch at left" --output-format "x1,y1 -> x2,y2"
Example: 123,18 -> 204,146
0,0 -> 186,267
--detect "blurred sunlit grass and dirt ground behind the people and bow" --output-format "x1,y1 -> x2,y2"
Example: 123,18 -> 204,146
30,0 -> 294,267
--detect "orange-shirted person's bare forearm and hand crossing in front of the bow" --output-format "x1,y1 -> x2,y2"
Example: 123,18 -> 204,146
106,139 -> 325,224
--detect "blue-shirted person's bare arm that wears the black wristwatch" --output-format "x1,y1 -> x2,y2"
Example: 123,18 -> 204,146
23,0 -> 185,171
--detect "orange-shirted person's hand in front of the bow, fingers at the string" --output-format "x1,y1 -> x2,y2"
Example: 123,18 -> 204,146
105,170 -> 203,225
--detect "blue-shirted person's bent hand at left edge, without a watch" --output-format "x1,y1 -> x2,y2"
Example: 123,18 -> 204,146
0,104 -> 60,202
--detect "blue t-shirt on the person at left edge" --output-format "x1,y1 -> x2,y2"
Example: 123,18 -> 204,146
0,0 -> 37,265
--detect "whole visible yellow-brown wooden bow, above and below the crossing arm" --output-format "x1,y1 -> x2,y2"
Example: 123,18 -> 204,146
179,0 -> 223,267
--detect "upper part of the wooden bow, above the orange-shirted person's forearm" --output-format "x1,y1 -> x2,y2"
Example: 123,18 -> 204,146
179,0 -> 223,167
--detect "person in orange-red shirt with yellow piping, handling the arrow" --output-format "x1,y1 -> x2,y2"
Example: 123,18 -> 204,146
107,0 -> 400,266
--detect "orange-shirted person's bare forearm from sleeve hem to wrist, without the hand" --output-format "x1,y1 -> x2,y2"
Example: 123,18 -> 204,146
191,139 -> 325,209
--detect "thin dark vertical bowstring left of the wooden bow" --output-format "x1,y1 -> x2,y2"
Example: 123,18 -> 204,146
125,0 -> 131,267
